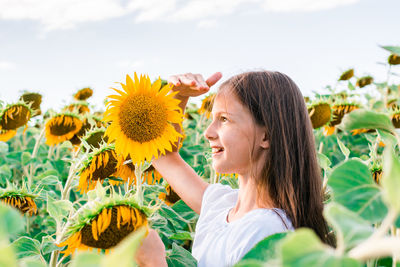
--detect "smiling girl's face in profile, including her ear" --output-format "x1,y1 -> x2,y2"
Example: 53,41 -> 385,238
204,90 -> 269,175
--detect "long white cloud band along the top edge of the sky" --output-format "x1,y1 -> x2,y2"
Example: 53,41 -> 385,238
0,0 -> 360,31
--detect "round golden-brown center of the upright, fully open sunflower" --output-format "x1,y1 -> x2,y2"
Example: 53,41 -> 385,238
119,94 -> 168,143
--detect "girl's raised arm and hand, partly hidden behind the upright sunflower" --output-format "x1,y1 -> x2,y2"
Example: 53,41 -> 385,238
152,72 -> 222,214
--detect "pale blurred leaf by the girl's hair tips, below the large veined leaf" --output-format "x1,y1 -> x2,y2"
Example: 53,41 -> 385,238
324,202 -> 374,250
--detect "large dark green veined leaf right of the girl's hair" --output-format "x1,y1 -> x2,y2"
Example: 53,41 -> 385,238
328,159 -> 387,223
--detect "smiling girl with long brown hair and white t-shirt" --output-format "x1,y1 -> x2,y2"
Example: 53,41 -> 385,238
136,71 -> 332,266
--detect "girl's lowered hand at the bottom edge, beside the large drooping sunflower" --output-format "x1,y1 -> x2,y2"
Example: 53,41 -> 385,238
135,229 -> 168,267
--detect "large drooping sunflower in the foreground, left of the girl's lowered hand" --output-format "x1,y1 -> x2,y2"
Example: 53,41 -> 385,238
57,194 -> 152,256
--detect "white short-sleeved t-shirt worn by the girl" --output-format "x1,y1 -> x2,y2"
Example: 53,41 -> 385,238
192,184 -> 293,267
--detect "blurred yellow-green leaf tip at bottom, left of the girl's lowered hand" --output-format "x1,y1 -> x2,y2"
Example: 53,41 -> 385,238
101,227 -> 146,267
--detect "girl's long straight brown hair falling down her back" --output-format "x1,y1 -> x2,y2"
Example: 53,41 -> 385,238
220,71 -> 334,245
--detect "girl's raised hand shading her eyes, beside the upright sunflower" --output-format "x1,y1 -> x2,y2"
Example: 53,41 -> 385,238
168,72 -> 222,97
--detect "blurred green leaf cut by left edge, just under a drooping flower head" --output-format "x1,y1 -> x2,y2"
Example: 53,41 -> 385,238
0,203 -> 25,239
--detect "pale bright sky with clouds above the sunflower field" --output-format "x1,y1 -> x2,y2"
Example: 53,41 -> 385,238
0,0 -> 400,110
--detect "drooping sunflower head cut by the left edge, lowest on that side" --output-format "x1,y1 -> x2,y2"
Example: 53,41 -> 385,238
0,185 -> 37,216
